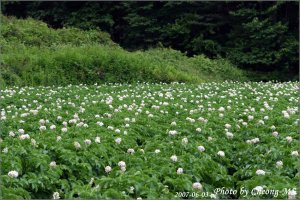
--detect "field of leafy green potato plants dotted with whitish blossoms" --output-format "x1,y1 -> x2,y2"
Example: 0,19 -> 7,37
0,82 -> 299,199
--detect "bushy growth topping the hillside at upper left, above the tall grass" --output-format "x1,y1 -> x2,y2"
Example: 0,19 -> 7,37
0,16 -> 116,52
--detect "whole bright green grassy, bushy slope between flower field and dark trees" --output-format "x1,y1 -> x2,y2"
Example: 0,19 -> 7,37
0,16 -> 247,86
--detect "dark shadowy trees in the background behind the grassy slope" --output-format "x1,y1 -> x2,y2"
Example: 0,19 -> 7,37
2,1 -> 299,73
